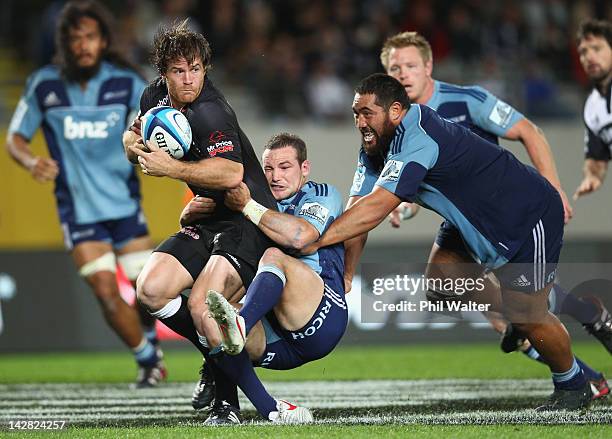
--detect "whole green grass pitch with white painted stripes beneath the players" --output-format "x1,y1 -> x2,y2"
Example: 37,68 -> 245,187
0,343 -> 612,438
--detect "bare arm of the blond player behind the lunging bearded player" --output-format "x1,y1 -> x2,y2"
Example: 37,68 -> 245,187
504,118 -> 573,223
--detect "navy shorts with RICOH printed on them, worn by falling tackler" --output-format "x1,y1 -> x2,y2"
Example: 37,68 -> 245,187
256,279 -> 348,370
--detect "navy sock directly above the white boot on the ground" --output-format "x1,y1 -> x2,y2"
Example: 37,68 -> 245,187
215,350 -> 276,419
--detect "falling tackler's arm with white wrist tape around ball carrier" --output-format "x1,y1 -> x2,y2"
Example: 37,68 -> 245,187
225,183 -> 319,250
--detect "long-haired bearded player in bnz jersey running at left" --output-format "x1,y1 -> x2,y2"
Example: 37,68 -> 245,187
7,1 -> 166,387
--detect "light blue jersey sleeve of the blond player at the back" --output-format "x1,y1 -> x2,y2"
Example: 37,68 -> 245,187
466,86 -> 525,137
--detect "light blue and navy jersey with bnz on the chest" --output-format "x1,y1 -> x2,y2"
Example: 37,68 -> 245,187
9,62 -> 146,224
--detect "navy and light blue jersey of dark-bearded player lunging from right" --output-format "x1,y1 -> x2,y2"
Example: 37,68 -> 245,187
351,104 -> 556,268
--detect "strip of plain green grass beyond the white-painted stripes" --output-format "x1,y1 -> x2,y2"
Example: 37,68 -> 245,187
0,342 -> 612,384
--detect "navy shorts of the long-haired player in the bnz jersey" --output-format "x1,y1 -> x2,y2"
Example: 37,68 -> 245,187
62,208 -> 149,250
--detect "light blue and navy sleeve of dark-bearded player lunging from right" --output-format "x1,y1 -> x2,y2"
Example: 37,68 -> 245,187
376,105 -> 439,200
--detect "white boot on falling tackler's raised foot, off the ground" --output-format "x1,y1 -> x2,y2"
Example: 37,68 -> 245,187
206,290 -> 246,355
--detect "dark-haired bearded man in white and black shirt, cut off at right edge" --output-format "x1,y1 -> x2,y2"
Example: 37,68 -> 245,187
574,20 -> 612,199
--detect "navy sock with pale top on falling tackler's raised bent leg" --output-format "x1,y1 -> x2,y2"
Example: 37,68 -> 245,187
240,265 -> 285,334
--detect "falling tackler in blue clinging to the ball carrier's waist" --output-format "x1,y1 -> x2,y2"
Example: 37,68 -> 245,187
207,133 -> 348,423
